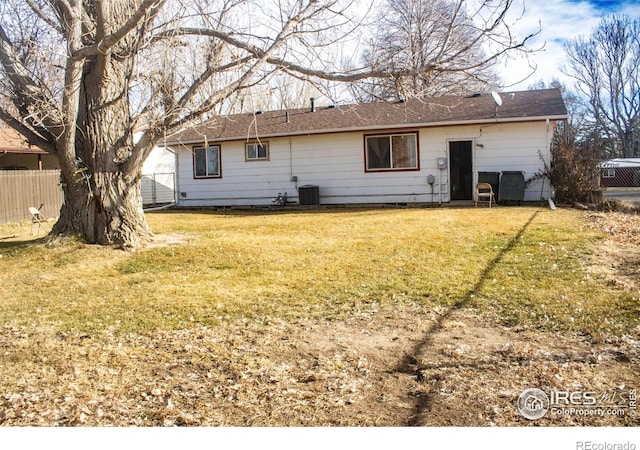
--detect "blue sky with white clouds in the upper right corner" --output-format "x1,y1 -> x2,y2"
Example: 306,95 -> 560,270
501,0 -> 640,91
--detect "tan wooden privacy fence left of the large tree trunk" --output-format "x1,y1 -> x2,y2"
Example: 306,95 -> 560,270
0,170 -> 62,224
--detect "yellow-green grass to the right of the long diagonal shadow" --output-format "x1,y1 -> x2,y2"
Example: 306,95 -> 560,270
473,211 -> 640,334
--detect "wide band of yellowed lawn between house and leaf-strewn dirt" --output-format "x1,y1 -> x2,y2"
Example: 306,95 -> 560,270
0,208 -> 639,333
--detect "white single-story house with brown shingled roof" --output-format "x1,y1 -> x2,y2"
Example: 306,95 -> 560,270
165,89 -> 567,207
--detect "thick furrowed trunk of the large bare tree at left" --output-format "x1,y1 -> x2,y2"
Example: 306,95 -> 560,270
52,2 -> 152,249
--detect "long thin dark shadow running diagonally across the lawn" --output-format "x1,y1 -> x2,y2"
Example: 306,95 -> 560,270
395,211 -> 538,426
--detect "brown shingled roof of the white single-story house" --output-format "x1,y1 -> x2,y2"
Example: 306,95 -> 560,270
167,89 -> 567,145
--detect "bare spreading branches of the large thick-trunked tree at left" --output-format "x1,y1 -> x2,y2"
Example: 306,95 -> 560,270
0,0 -> 540,148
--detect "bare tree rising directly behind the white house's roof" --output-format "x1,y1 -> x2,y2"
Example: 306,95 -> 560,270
358,0 -> 535,99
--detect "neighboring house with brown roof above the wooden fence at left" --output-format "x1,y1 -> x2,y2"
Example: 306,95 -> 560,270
0,122 -> 60,170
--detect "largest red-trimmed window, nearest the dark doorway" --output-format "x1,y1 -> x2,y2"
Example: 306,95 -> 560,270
364,132 -> 420,172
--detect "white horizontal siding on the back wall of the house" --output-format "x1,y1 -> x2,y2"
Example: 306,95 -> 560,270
176,122 -> 549,206
